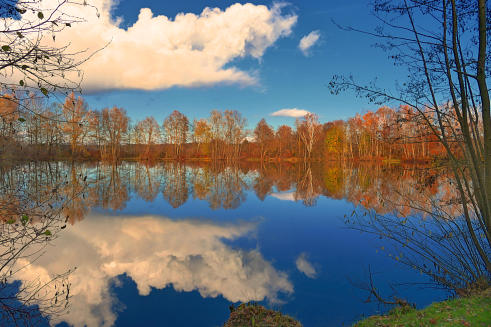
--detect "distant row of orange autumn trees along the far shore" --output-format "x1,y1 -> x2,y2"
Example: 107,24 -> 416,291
0,93 -> 472,161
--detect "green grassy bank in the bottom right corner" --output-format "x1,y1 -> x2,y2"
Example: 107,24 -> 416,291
353,288 -> 491,327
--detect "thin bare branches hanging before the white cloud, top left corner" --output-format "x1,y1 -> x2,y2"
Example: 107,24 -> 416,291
0,0 -> 99,95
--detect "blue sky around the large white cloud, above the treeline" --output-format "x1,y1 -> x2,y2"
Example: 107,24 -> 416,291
78,0 -> 404,128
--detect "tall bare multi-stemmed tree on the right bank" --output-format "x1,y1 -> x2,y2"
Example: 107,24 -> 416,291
330,0 -> 491,282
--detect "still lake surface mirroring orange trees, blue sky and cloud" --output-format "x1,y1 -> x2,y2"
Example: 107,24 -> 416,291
0,162 -> 449,326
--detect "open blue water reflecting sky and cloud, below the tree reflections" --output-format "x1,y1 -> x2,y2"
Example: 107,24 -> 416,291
2,164 -> 448,327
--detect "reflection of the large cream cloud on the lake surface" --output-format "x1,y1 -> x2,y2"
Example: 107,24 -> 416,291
9,215 -> 293,327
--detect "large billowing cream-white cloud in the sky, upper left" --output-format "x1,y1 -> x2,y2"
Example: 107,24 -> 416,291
3,0 -> 297,92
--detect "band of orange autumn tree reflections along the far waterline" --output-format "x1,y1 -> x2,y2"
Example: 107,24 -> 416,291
0,163 -> 458,220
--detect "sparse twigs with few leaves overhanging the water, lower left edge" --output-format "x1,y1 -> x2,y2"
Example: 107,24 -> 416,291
0,163 -> 87,326
